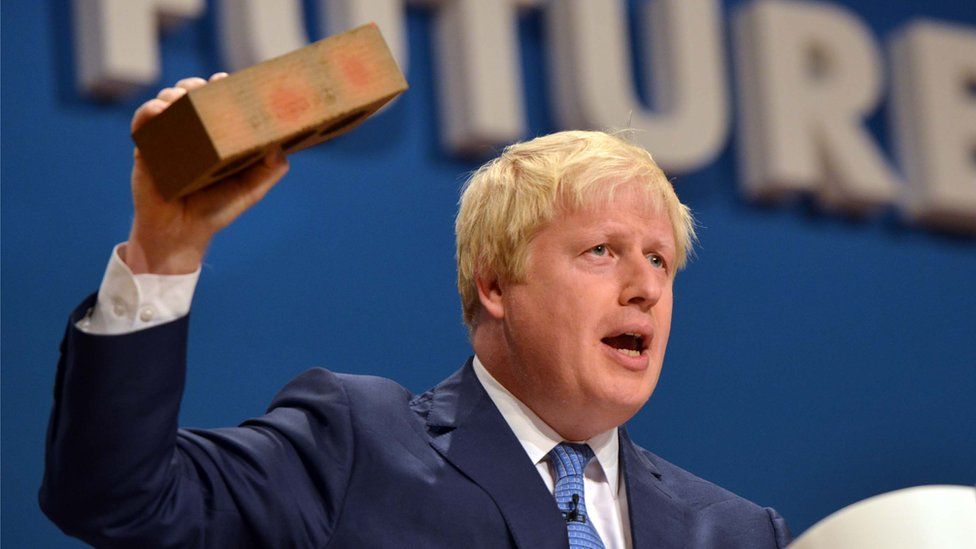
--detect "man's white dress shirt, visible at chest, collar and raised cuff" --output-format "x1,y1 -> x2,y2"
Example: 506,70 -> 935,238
82,244 -> 631,549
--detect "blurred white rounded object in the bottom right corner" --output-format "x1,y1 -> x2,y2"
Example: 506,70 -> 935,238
790,486 -> 976,549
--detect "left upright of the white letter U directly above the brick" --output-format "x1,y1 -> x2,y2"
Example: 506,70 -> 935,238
218,0 -> 308,71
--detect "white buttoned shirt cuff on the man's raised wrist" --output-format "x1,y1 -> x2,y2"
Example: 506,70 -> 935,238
75,243 -> 200,335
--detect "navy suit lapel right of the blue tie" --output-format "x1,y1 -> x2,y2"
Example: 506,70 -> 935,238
619,427 -> 691,548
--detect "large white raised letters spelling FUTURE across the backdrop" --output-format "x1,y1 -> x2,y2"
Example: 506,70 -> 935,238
74,0 -> 976,234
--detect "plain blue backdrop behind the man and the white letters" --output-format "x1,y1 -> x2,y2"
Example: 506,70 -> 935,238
0,0 -> 976,547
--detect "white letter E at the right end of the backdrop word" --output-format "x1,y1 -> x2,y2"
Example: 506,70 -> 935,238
891,22 -> 976,233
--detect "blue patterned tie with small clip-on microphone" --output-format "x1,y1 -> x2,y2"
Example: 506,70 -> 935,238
548,442 -> 604,549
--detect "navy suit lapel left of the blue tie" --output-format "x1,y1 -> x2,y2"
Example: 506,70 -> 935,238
427,359 -> 569,549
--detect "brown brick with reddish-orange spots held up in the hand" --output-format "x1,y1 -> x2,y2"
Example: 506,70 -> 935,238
132,24 -> 407,200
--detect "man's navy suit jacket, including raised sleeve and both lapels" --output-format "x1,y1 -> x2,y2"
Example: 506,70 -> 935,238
40,298 -> 789,549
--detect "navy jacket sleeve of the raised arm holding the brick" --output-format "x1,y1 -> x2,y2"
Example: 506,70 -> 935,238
40,297 -> 354,547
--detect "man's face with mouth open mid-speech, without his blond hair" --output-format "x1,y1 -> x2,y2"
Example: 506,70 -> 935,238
501,184 -> 676,437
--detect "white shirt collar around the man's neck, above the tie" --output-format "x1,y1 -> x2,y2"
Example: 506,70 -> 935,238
473,355 -> 620,497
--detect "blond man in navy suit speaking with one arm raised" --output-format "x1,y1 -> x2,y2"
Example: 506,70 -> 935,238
41,75 -> 789,548
